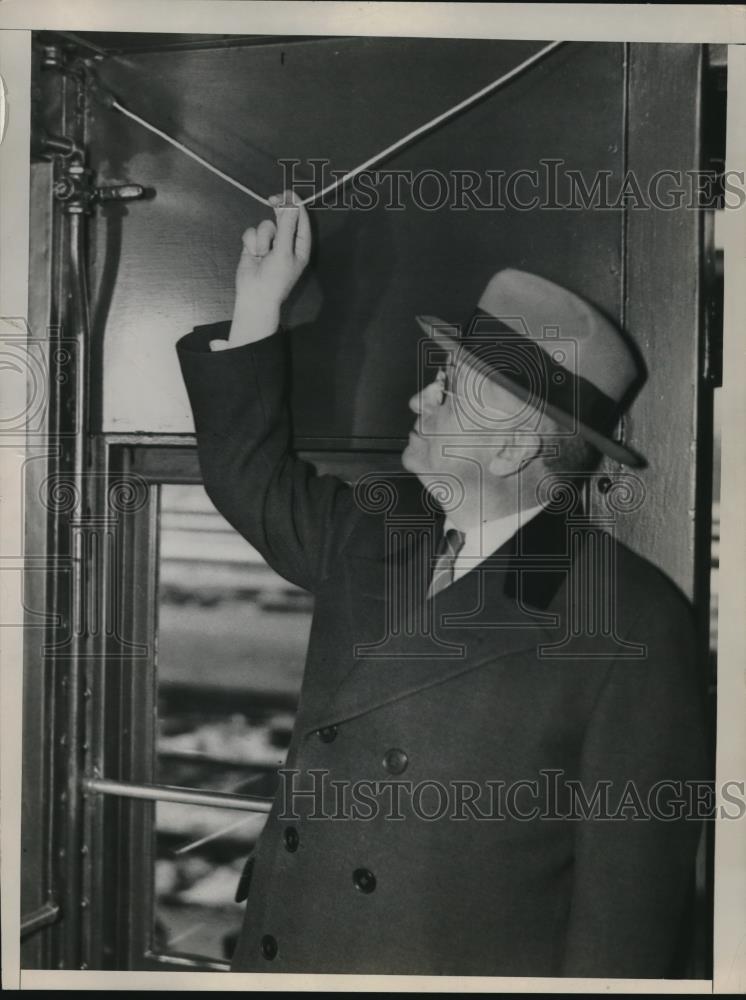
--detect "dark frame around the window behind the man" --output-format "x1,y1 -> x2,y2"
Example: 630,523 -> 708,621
80,434 -> 399,972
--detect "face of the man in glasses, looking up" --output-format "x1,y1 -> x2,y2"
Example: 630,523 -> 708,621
401,358 -> 523,500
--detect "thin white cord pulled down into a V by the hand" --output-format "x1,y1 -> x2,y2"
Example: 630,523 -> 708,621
106,41 -> 564,207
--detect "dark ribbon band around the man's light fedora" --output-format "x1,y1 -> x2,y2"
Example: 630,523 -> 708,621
448,309 -> 619,434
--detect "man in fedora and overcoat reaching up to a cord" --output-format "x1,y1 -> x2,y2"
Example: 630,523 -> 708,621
178,195 -> 705,977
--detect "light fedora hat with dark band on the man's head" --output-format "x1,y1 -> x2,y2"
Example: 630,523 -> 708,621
417,268 -> 645,467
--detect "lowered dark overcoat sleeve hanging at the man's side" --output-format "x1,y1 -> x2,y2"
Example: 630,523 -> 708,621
563,584 -> 709,978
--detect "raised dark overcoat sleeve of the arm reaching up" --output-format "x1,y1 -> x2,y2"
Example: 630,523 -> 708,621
176,323 -> 353,591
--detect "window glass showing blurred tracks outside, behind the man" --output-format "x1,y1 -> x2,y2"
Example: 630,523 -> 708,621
153,485 -> 312,959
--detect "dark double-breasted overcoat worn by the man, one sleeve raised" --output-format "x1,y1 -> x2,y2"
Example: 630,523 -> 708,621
177,324 -> 707,977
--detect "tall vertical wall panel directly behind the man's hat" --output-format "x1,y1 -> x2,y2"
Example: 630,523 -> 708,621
618,45 -> 700,597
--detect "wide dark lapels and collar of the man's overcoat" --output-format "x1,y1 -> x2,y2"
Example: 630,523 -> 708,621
308,494 -> 568,729
